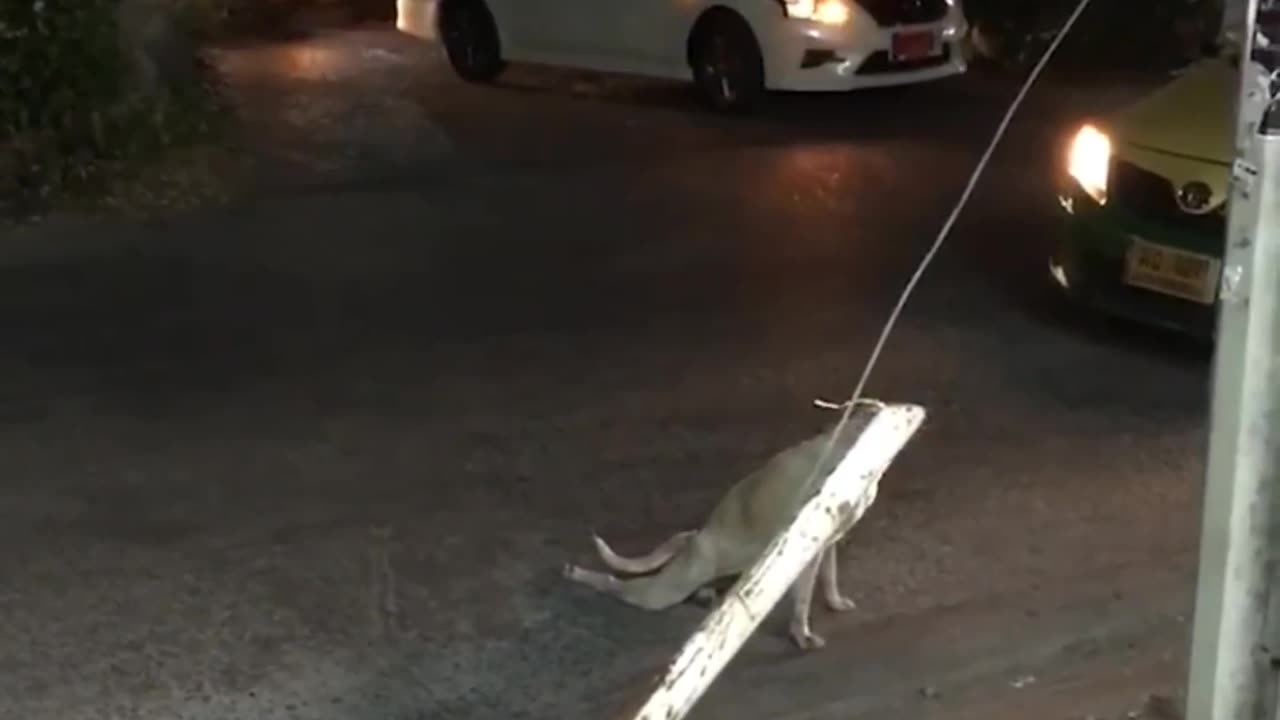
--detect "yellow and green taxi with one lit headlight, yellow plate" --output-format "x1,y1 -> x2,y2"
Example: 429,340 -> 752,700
1048,54 -> 1239,338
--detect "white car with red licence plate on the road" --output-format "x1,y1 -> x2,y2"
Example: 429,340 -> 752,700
398,0 -> 968,111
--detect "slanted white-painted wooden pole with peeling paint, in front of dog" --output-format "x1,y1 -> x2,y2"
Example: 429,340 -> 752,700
616,405 -> 924,720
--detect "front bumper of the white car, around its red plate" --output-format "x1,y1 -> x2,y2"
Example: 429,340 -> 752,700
760,5 -> 968,92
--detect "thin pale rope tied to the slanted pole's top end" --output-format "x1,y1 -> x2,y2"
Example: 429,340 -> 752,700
809,0 -> 1089,482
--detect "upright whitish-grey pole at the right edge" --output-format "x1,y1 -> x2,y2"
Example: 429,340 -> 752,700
1187,0 -> 1280,720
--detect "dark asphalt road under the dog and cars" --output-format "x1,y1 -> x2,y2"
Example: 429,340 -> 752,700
0,25 -> 1207,720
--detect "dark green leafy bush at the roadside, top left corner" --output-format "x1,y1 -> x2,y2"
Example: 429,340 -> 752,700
0,0 -> 227,210
